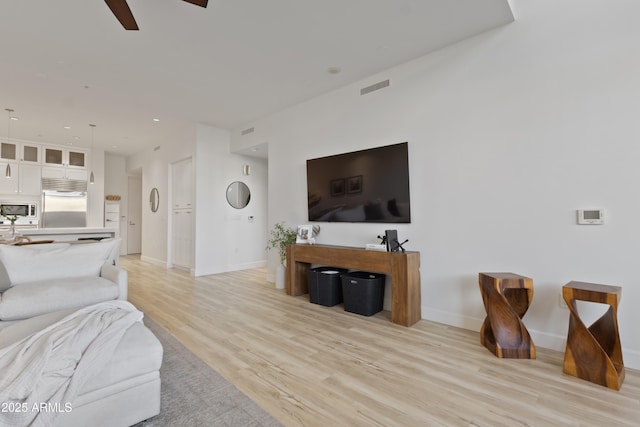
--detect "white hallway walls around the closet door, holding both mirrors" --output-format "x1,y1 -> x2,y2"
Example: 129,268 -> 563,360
127,125 -> 267,276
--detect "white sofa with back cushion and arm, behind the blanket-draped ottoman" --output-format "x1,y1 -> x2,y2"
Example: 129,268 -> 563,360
0,239 -> 127,329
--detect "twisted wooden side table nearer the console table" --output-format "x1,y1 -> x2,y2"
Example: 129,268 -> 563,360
478,273 -> 536,359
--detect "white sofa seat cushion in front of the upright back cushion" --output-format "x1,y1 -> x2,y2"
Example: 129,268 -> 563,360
0,276 -> 119,320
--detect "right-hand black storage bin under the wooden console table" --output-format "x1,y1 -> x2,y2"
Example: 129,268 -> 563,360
342,271 -> 386,316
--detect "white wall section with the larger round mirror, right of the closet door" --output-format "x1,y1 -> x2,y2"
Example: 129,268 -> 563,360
195,125 -> 267,276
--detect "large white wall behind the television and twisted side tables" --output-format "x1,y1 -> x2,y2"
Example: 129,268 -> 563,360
233,0 -> 640,369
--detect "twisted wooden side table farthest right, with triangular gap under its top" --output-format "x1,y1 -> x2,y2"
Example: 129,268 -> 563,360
562,282 -> 624,390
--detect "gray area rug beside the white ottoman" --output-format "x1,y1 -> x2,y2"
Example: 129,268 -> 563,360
135,316 -> 281,427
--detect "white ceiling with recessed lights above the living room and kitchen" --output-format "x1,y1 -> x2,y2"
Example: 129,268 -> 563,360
0,0 -> 513,155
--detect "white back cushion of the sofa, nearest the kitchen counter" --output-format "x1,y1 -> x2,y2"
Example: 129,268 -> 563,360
0,239 -> 119,287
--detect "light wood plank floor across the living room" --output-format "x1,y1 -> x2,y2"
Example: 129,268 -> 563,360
121,256 -> 640,427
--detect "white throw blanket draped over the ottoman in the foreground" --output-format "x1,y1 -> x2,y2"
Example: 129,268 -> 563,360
0,301 -> 143,427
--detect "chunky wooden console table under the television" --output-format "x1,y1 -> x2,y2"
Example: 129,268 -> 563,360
285,244 -> 422,326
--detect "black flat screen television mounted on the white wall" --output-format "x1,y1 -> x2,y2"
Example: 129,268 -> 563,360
307,142 -> 411,223
